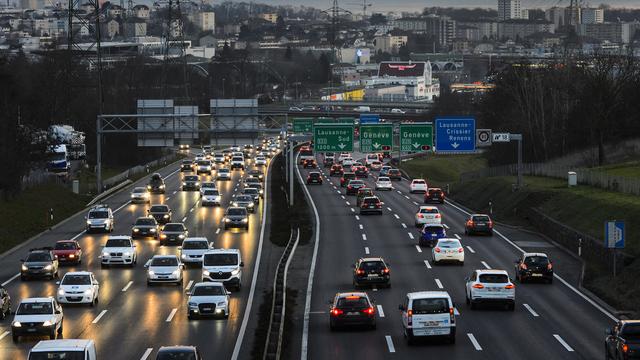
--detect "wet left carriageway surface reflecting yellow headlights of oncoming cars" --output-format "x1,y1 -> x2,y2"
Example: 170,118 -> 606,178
0,153 -> 264,360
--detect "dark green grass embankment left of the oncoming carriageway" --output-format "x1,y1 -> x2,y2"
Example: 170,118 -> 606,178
0,184 -> 91,253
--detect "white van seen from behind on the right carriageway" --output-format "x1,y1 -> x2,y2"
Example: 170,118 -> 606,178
398,291 -> 456,345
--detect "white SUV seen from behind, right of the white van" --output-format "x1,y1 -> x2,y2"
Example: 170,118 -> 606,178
465,269 -> 516,311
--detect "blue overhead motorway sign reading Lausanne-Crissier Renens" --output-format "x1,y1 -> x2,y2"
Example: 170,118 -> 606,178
435,117 -> 476,153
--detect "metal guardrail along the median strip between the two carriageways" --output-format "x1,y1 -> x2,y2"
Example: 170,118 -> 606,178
262,229 -> 300,360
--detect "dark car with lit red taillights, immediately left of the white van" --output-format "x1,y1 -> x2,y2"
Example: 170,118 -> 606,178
329,292 -> 376,331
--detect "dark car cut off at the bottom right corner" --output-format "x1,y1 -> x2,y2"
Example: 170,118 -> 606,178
604,320 -> 640,360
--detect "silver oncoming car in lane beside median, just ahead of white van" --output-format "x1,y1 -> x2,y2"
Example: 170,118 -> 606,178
187,282 -> 231,320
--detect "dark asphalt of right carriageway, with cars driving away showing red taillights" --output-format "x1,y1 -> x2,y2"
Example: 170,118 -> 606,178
299,154 -> 615,360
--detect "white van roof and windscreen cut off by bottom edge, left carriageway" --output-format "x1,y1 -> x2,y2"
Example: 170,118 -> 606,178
29,339 -> 97,360
